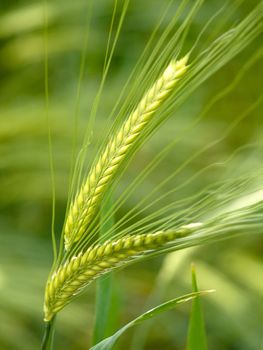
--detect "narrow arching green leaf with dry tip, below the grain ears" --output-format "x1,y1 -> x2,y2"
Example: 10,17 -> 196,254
91,290 -> 213,350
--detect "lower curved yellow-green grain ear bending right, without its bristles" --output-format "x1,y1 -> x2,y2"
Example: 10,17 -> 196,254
44,223 -> 198,322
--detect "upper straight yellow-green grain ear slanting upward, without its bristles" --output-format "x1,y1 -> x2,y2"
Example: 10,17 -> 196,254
64,56 -> 188,249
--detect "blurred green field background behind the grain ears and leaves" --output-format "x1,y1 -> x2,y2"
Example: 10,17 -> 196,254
0,0 -> 263,350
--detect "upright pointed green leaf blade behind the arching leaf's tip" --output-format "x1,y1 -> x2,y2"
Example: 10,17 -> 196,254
187,265 -> 210,350
